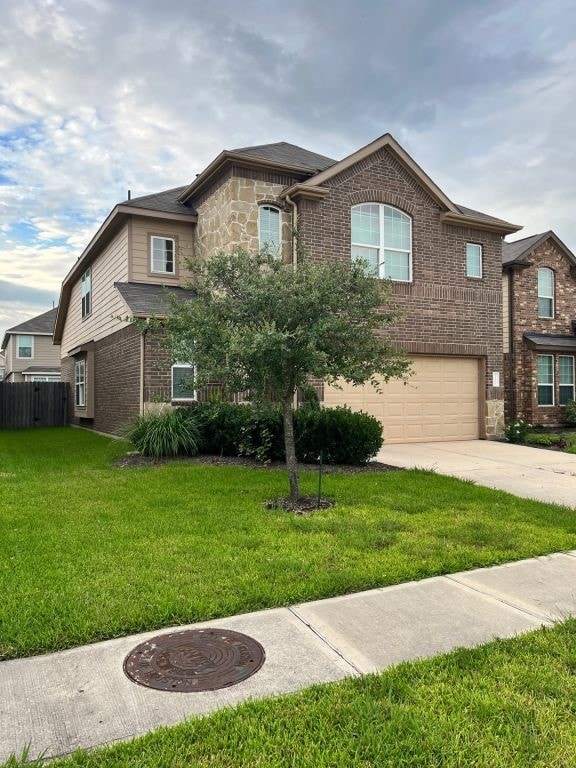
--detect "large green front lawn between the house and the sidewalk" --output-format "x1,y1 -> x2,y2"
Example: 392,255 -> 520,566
0,428 -> 576,658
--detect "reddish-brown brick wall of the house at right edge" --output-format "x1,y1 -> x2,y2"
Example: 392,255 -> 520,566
504,239 -> 576,426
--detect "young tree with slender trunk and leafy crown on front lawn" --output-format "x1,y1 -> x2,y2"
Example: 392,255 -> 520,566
166,250 -> 409,501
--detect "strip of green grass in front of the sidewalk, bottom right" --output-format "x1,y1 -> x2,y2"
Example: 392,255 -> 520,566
8,620 -> 576,768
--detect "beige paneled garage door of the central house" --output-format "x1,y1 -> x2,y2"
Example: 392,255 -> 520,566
324,357 -> 479,443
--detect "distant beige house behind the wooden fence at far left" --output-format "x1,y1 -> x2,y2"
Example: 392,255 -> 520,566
1,308 -> 60,383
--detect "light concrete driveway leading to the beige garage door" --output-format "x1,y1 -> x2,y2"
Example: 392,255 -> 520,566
377,440 -> 576,508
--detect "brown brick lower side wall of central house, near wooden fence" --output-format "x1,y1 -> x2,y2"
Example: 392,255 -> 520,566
62,326 -> 140,434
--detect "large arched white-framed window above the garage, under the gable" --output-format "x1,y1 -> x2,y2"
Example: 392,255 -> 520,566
352,203 -> 412,283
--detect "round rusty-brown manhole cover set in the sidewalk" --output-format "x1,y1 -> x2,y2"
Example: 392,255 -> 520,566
124,629 -> 266,692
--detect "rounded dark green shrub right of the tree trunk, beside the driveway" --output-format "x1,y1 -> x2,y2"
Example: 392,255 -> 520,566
294,406 -> 382,464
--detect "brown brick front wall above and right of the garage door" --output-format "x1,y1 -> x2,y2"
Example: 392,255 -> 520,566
299,144 -> 504,432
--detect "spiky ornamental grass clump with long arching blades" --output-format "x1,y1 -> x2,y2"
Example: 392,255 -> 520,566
124,408 -> 200,459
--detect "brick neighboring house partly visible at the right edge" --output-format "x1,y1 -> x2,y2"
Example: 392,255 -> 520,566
502,231 -> 576,426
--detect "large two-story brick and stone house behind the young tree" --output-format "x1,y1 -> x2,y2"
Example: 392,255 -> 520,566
54,134 -> 519,442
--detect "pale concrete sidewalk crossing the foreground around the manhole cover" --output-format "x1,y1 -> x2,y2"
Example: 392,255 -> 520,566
0,551 -> 576,761
